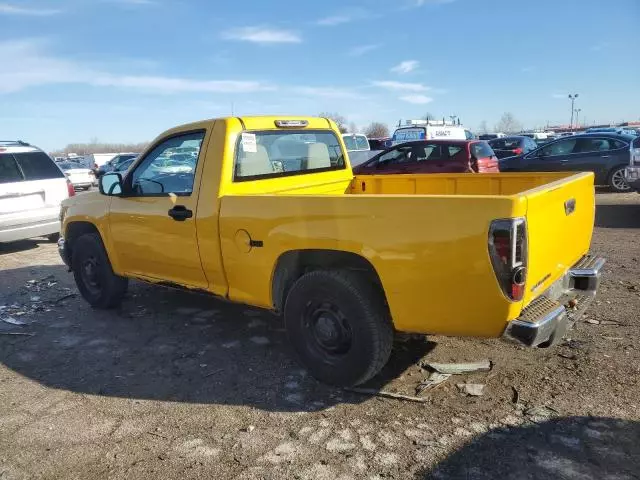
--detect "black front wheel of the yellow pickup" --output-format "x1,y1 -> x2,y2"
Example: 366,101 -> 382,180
71,233 -> 129,309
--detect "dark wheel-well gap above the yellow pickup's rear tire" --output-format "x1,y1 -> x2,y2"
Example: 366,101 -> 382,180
271,249 -> 387,312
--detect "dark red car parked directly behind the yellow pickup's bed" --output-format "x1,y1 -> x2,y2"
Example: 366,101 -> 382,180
353,140 -> 499,175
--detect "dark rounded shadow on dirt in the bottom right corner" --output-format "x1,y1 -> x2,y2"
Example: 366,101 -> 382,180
416,417 -> 640,480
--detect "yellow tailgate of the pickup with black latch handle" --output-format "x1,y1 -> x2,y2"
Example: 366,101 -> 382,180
524,173 -> 595,305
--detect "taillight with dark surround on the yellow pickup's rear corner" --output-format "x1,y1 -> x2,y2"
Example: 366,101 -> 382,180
489,218 -> 527,301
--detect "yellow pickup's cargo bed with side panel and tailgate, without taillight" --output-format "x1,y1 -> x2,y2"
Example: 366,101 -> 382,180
219,173 -> 594,336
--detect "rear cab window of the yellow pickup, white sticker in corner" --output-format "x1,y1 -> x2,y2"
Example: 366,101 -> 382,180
234,130 -> 346,181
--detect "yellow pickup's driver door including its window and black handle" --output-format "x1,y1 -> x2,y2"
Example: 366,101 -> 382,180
109,130 -> 208,288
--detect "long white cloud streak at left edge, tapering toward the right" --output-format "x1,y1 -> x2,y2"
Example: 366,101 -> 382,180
0,40 -> 276,94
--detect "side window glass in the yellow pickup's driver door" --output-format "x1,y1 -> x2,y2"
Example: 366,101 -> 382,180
131,131 -> 205,196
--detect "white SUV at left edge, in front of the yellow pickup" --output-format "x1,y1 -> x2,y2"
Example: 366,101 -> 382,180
0,141 -> 74,242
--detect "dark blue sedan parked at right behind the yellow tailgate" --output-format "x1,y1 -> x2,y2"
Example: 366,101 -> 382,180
500,133 -> 635,192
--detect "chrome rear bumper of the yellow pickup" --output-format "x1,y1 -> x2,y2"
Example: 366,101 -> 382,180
505,255 -> 605,347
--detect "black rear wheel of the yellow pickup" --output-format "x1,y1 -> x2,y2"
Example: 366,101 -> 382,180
284,270 -> 393,387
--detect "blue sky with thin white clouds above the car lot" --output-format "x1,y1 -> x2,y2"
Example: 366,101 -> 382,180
0,0 -> 640,150
